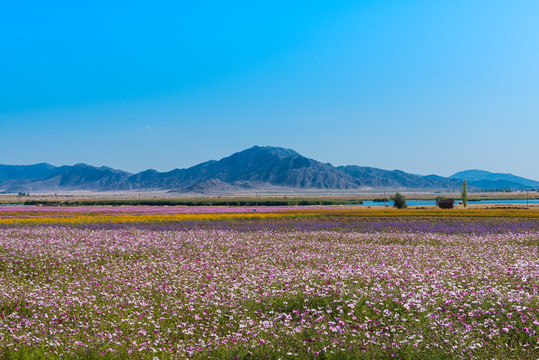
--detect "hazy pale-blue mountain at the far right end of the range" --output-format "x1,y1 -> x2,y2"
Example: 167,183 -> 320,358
450,170 -> 539,189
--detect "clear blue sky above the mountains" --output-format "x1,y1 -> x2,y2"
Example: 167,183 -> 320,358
0,0 -> 539,180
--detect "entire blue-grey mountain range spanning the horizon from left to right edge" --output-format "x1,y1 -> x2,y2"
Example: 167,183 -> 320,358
0,146 -> 539,193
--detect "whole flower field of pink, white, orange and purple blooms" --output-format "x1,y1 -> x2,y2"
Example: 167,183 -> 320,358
0,207 -> 539,359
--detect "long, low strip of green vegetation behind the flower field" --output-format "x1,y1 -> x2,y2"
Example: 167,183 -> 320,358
23,198 -> 363,206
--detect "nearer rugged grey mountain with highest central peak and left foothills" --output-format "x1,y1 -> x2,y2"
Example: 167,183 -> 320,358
0,146 -> 360,192
